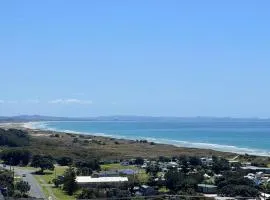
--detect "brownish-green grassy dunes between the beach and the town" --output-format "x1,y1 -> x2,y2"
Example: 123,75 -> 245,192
27,130 -> 235,162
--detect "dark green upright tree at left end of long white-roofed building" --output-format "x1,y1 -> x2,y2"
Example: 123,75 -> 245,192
63,167 -> 78,195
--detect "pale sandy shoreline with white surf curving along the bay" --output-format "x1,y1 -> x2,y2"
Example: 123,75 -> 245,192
0,121 -> 270,157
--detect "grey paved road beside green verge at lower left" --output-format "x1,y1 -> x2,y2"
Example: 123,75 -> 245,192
0,164 -> 46,199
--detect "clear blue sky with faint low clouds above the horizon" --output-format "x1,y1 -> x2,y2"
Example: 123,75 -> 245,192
0,0 -> 270,117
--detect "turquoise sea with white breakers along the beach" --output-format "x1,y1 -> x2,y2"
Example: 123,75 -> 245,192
32,120 -> 270,156
